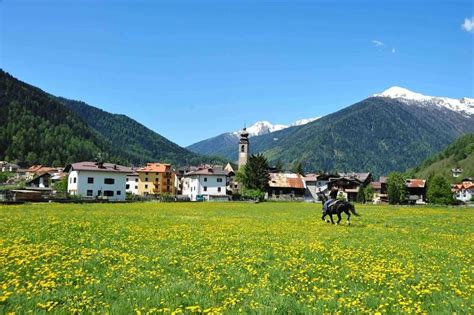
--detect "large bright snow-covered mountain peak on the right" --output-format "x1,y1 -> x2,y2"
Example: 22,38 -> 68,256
373,86 -> 474,116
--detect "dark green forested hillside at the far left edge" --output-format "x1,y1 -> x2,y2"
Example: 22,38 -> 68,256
0,70 -> 109,166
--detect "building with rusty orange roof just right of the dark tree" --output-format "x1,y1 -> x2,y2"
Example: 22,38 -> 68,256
265,171 -> 306,200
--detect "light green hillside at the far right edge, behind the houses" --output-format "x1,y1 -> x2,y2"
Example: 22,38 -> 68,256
414,133 -> 474,182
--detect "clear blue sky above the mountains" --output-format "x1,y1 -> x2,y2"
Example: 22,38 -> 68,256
0,0 -> 474,146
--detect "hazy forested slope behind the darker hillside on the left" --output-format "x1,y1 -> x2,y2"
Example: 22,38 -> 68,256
58,98 -> 223,165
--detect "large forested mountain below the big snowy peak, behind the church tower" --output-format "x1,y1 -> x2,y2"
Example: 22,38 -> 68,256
193,97 -> 474,175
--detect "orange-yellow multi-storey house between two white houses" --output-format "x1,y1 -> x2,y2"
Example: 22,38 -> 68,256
136,163 -> 176,196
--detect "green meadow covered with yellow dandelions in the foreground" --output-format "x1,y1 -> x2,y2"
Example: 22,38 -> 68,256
0,203 -> 474,314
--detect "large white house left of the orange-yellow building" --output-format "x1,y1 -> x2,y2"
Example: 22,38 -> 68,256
65,162 -> 131,201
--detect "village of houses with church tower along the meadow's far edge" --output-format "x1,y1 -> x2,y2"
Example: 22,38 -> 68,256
0,129 -> 474,205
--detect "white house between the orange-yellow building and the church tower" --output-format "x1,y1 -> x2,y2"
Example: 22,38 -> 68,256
182,167 -> 228,201
